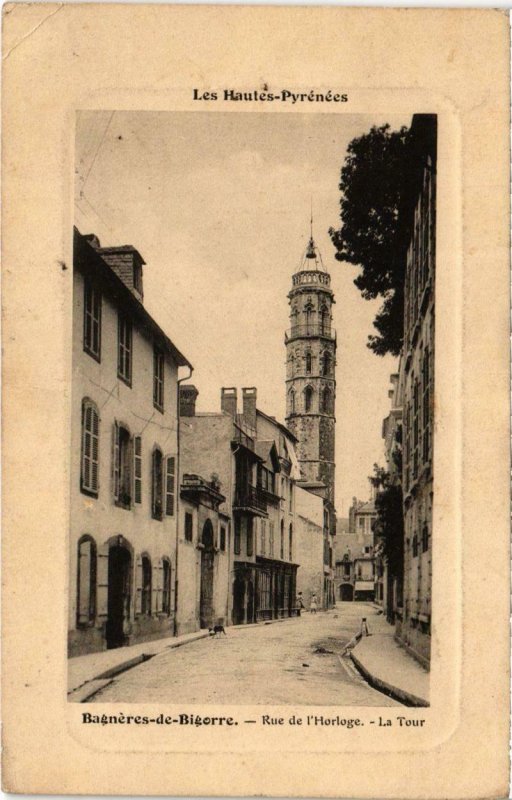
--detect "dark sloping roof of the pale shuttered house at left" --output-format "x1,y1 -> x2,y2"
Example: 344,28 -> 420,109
73,228 -> 193,369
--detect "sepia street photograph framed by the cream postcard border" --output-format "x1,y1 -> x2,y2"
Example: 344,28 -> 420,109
68,110 -> 437,706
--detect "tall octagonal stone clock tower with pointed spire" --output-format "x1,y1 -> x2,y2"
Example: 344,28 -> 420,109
285,236 -> 336,606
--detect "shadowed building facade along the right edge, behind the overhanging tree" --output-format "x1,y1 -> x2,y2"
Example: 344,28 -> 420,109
397,114 -> 437,664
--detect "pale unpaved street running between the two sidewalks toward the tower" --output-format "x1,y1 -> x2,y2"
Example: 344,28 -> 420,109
93,603 -> 400,706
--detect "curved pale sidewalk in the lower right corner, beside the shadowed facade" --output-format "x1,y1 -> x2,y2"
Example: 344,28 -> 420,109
351,616 -> 430,706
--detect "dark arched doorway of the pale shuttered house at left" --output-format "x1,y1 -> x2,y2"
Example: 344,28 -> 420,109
106,546 -> 132,650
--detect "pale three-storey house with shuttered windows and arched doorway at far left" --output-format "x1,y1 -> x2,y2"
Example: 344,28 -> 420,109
68,230 -> 190,655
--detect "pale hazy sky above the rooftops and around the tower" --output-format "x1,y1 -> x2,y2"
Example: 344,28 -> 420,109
75,111 -> 410,516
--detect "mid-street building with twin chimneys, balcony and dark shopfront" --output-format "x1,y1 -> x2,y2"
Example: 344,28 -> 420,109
180,386 -> 298,624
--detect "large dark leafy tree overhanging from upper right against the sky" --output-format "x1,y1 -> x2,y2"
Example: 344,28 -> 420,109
329,125 -> 411,356
